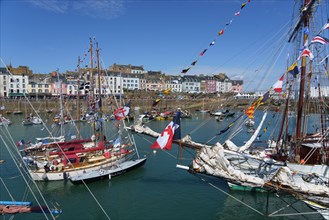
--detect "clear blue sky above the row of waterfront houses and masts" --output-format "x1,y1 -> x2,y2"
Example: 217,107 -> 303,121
0,0 -> 294,90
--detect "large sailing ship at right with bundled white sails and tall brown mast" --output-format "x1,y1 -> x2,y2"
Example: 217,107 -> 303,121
182,0 -> 329,219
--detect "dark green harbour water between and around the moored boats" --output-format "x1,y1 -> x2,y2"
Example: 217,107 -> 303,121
0,111 -> 322,220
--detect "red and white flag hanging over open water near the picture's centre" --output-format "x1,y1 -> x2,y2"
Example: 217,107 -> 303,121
151,122 -> 175,150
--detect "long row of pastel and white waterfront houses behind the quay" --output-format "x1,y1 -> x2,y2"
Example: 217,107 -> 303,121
0,64 -> 243,97
